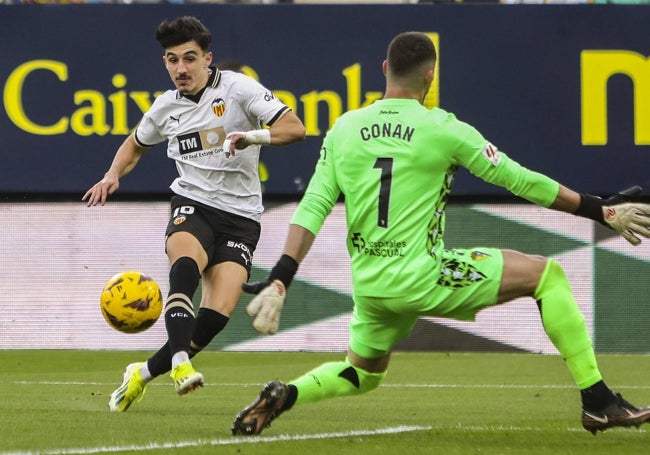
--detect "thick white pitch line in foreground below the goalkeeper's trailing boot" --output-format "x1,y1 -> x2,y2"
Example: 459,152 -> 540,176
0,426 -> 433,455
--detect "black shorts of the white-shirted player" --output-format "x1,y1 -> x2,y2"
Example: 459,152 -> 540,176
165,196 -> 260,274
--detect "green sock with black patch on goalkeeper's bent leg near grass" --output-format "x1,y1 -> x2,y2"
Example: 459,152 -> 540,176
289,359 -> 386,405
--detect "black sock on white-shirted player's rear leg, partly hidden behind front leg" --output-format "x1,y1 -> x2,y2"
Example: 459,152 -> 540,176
146,308 -> 230,380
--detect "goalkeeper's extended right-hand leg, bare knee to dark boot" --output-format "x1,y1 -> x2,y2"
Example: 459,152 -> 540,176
498,251 -> 650,433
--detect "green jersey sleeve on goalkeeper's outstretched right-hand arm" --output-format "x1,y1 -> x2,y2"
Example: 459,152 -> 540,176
456,124 -> 560,207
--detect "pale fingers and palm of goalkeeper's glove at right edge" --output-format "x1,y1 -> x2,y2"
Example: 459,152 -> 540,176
603,202 -> 650,245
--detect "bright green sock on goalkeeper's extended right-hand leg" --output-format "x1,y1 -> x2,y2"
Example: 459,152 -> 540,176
533,259 -> 602,389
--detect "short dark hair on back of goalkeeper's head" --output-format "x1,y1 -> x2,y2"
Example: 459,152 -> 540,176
386,32 -> 437,76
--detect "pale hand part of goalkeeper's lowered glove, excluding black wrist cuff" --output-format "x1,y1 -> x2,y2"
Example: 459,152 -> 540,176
242,280 -> 287,335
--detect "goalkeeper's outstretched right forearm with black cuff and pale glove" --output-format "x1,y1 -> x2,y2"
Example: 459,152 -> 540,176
550,185 -> 650,245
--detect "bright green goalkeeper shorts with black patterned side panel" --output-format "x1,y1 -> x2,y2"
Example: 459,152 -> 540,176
350,248 -> 503,359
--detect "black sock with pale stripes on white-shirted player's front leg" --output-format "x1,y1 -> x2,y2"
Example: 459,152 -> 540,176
165,257 -> 201,364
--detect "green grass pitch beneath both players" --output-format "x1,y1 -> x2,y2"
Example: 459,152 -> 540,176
0,350 -> 650,455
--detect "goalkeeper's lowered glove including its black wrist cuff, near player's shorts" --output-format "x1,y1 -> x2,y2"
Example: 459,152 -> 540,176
242,254 -> 298,335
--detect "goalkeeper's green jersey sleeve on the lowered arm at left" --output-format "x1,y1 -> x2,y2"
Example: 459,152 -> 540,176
291,129 -> 341,235
